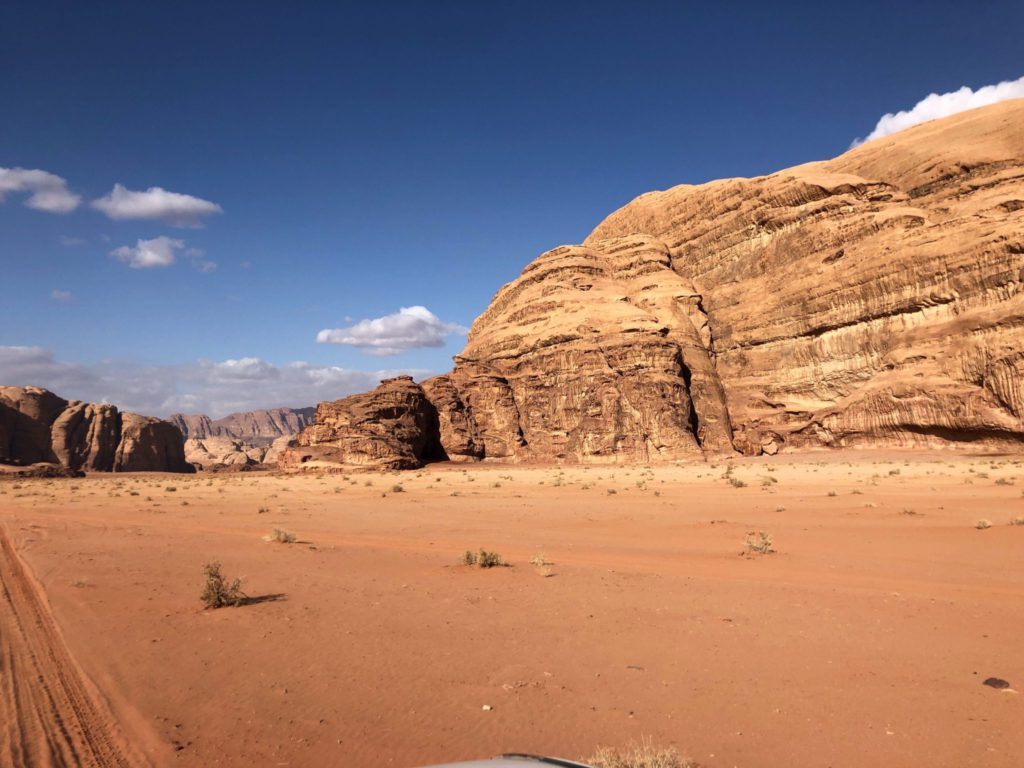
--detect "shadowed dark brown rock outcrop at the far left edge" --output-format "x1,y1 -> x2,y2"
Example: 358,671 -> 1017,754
0,387 -> 194,472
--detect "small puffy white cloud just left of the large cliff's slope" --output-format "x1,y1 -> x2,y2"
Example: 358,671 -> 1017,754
316,306 -> 466,355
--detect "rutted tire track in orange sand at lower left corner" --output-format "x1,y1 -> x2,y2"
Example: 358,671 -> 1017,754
0,526 -> 140,768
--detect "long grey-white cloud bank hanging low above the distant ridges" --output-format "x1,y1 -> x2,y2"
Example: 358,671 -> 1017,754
0,346 -> 430,418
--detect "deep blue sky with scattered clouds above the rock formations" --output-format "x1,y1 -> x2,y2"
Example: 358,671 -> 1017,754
0,0 -> 1024,415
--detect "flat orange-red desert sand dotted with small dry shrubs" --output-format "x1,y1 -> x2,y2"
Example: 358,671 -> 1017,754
0,453 -> 1024,768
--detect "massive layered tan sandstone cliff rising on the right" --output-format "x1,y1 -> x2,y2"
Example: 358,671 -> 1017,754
283,100 -> 1024,466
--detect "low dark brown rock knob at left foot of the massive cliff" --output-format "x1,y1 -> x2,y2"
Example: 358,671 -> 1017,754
279,376 -> 440,469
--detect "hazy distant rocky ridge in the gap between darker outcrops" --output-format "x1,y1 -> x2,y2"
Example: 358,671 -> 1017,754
168,408 -> 315,469
